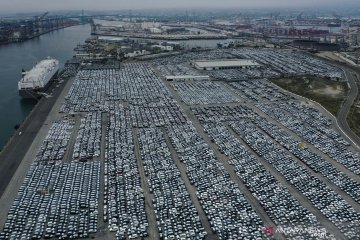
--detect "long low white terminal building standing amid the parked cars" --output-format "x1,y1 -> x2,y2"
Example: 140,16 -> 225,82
191,59 -> 261,70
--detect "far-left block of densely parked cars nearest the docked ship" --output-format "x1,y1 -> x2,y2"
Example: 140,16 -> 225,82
61,63 -> 167,113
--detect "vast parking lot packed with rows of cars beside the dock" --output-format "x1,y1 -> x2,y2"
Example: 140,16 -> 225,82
0,50 -> 360,240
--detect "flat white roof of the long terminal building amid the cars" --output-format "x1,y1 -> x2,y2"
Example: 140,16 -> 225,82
194,59 -> 260,68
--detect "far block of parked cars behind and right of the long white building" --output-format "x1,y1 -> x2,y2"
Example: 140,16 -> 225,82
232,48 -> 344,79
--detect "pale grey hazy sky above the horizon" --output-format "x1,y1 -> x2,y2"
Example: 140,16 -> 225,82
0,0 -> 360,13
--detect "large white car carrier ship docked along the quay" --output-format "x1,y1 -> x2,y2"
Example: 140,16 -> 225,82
18,58 -> 59,98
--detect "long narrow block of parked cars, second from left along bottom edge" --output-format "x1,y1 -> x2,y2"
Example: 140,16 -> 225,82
103,103 -> 149,240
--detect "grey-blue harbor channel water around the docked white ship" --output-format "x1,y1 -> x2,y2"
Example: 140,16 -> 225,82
0,25 -> 90,149
